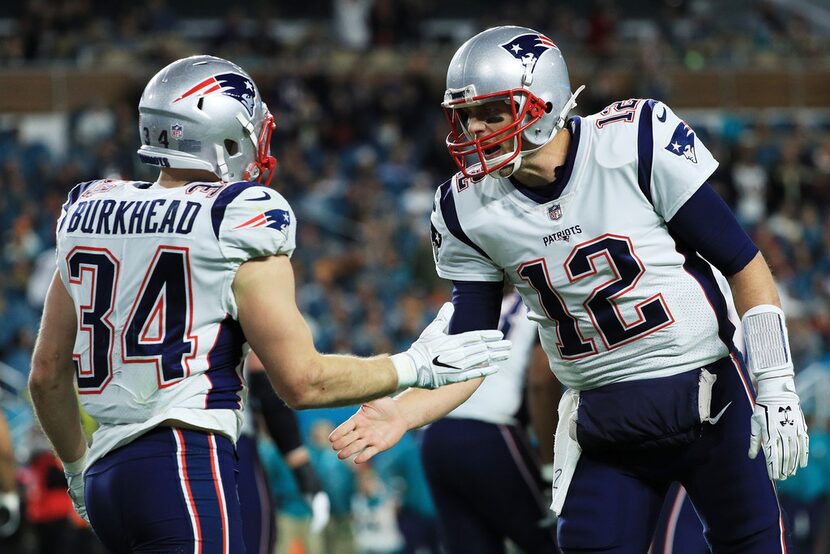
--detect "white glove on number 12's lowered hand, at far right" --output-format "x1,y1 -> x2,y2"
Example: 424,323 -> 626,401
749,377 -> 810,481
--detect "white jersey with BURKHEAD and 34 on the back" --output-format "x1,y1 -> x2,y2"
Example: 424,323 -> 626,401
57,180 -> 296,464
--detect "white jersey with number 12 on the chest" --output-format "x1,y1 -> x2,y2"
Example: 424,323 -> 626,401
432,99 -> 731,390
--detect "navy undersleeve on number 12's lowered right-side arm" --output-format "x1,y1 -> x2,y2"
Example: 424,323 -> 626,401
667,182 -> 758,277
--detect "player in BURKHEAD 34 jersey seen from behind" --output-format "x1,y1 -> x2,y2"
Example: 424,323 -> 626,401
29,52 -> 509,553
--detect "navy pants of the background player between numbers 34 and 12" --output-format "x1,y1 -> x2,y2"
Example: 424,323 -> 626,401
421,418 -> 557,554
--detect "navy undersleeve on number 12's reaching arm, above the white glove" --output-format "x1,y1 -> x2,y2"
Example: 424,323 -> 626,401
449,281 -> 504,335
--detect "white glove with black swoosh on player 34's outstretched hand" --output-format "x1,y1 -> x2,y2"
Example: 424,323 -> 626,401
392,302 -> 511,389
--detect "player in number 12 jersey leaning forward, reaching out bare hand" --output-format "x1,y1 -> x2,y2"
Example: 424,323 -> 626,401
331,26 -> 808,554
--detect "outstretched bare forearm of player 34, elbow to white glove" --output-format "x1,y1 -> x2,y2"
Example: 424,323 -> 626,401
275,354 -> 398,410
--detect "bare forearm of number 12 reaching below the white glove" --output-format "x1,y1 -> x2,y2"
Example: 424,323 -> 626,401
395,378 -> 484,429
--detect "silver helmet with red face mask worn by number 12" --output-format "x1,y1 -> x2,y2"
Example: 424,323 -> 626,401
441,26 -> 584,177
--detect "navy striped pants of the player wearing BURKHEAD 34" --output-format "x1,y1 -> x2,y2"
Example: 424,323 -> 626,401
84,427 -> 245,554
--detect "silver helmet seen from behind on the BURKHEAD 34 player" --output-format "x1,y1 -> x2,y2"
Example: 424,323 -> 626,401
138,56 -> 277,185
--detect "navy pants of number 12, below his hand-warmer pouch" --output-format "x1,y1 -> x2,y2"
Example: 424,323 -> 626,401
558,357 -> 788,554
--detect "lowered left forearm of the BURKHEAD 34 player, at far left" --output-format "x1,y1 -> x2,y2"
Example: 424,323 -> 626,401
29,366 -> 86,462
